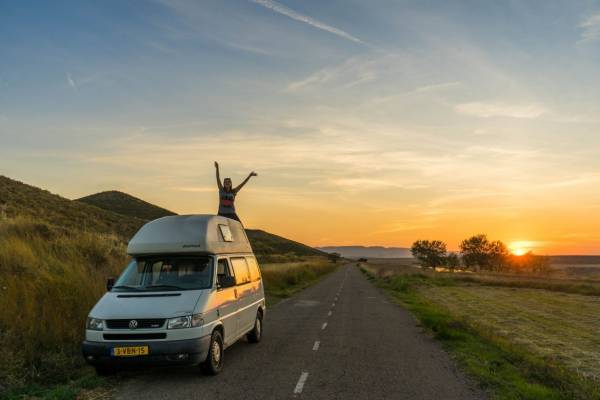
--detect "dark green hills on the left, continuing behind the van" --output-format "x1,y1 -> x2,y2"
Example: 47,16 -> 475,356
0,175 -> 325,259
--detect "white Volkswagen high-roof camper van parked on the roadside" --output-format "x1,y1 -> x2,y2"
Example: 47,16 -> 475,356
82,215 -> 266,374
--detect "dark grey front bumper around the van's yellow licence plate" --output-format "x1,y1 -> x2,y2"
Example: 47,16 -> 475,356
81,335 -> 210,366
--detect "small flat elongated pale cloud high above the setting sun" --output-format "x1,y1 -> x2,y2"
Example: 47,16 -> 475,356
454,102 -> 546,119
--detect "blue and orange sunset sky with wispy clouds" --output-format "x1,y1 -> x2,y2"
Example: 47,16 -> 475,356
0,0 -> 600,254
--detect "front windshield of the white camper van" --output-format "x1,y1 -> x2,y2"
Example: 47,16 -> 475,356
112,256 -> 213,292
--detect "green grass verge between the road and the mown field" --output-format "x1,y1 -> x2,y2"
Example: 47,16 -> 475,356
362,268 -> 600,400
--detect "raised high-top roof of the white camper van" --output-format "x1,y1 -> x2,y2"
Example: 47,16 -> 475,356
127,215 -> 252,256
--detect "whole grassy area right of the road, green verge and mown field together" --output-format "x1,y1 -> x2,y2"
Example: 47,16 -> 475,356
363,263 -> 600,400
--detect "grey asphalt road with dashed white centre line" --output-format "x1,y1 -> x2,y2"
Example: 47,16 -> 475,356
117,265 -> 485,400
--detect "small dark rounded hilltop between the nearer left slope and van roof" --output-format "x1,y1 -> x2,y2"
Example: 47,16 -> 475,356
77,190 -> 176,220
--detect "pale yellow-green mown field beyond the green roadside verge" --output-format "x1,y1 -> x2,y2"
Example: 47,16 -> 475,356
420,286 -> 600,385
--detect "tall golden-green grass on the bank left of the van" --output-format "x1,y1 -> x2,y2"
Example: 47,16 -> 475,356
0,219 -> 127,392
